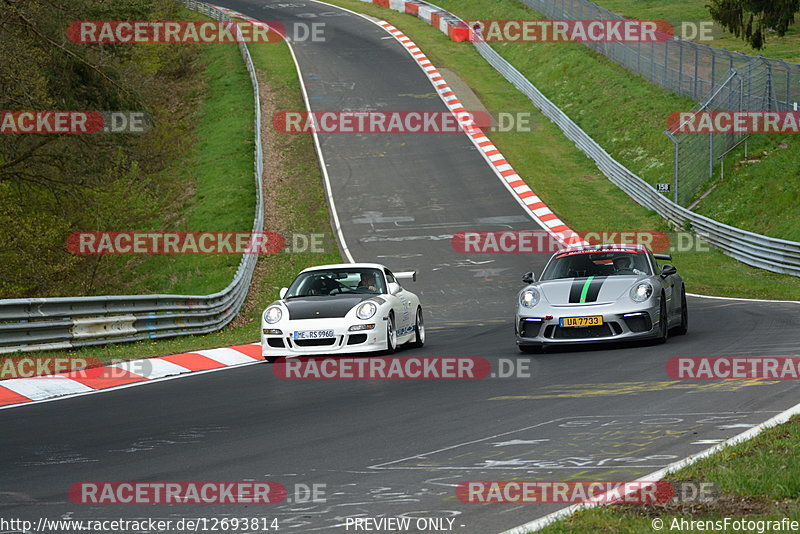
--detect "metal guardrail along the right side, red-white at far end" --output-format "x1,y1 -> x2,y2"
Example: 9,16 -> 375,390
350,0 -> 800,276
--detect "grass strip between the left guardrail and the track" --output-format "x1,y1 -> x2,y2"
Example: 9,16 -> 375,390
2,31 -> 341,362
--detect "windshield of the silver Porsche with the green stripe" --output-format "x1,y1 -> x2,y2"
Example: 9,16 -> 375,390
541,250 -> 653,280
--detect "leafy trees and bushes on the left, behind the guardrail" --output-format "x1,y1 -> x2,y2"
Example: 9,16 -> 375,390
0,0 -> 199,298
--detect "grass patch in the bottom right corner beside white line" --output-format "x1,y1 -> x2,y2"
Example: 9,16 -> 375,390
539,417 -> 800,534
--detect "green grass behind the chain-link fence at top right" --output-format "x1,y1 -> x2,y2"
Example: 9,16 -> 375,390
595,0 -> 800,63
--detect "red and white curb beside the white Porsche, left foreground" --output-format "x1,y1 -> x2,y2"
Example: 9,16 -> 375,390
0,343 -> 263,406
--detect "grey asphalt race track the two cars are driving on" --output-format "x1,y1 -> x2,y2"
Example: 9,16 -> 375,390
0,0 -> 800,534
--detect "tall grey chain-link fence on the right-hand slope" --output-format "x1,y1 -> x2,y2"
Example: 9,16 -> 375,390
522,0 -> 800,206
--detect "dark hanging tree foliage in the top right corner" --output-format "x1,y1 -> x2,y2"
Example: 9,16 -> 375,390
707,0 -> 800,50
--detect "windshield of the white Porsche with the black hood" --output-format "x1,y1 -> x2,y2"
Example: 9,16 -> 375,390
284,268 -> 386,299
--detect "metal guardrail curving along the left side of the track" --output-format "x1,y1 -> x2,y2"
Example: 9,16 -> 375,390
0,0 -> 264,354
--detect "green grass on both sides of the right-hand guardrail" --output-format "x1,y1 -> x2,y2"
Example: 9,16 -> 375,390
328,0 -> 800,300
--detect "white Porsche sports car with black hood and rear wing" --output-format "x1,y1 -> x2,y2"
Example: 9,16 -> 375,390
261,263 -> 425,361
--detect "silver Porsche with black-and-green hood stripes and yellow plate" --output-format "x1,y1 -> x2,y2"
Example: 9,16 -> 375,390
514,245 -> 689,352
